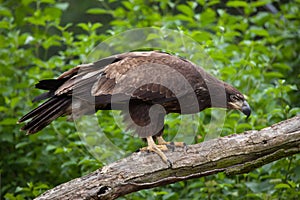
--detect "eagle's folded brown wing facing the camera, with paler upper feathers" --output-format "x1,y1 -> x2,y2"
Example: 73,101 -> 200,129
56,51 -> 200,104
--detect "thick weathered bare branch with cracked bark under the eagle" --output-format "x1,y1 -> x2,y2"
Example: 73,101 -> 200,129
36,116 -> 300,200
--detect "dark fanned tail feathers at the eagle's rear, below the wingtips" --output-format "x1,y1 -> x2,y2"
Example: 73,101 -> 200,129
19,97 -> 71,134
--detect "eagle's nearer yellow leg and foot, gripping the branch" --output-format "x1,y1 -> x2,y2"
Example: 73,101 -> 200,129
140,136 -> 172,167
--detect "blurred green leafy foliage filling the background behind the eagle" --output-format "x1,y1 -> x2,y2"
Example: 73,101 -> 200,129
0,0 -> 300,200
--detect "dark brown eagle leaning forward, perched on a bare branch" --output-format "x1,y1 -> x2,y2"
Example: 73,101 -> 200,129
18,51 -> 251,165
